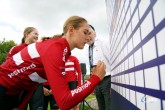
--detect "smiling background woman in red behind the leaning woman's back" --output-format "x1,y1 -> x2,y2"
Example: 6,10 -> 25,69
4,27 -> 43,110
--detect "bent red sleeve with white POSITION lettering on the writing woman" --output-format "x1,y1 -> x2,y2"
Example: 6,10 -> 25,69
42,45 -> 100,110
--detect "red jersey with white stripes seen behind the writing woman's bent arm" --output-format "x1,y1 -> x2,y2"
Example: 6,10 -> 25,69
65,56 -> 82,86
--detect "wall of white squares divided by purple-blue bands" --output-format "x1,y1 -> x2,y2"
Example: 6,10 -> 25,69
106,0 -> 165,110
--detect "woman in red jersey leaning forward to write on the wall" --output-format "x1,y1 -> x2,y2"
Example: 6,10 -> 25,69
0,16 -> 105,110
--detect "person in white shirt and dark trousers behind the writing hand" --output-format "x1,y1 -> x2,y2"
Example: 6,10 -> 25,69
87,25 -> 111,110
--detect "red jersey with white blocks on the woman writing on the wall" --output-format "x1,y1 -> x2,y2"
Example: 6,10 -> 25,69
0,38 -> 100,110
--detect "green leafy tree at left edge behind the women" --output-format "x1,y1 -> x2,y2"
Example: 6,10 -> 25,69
0,40 -> 16,64
